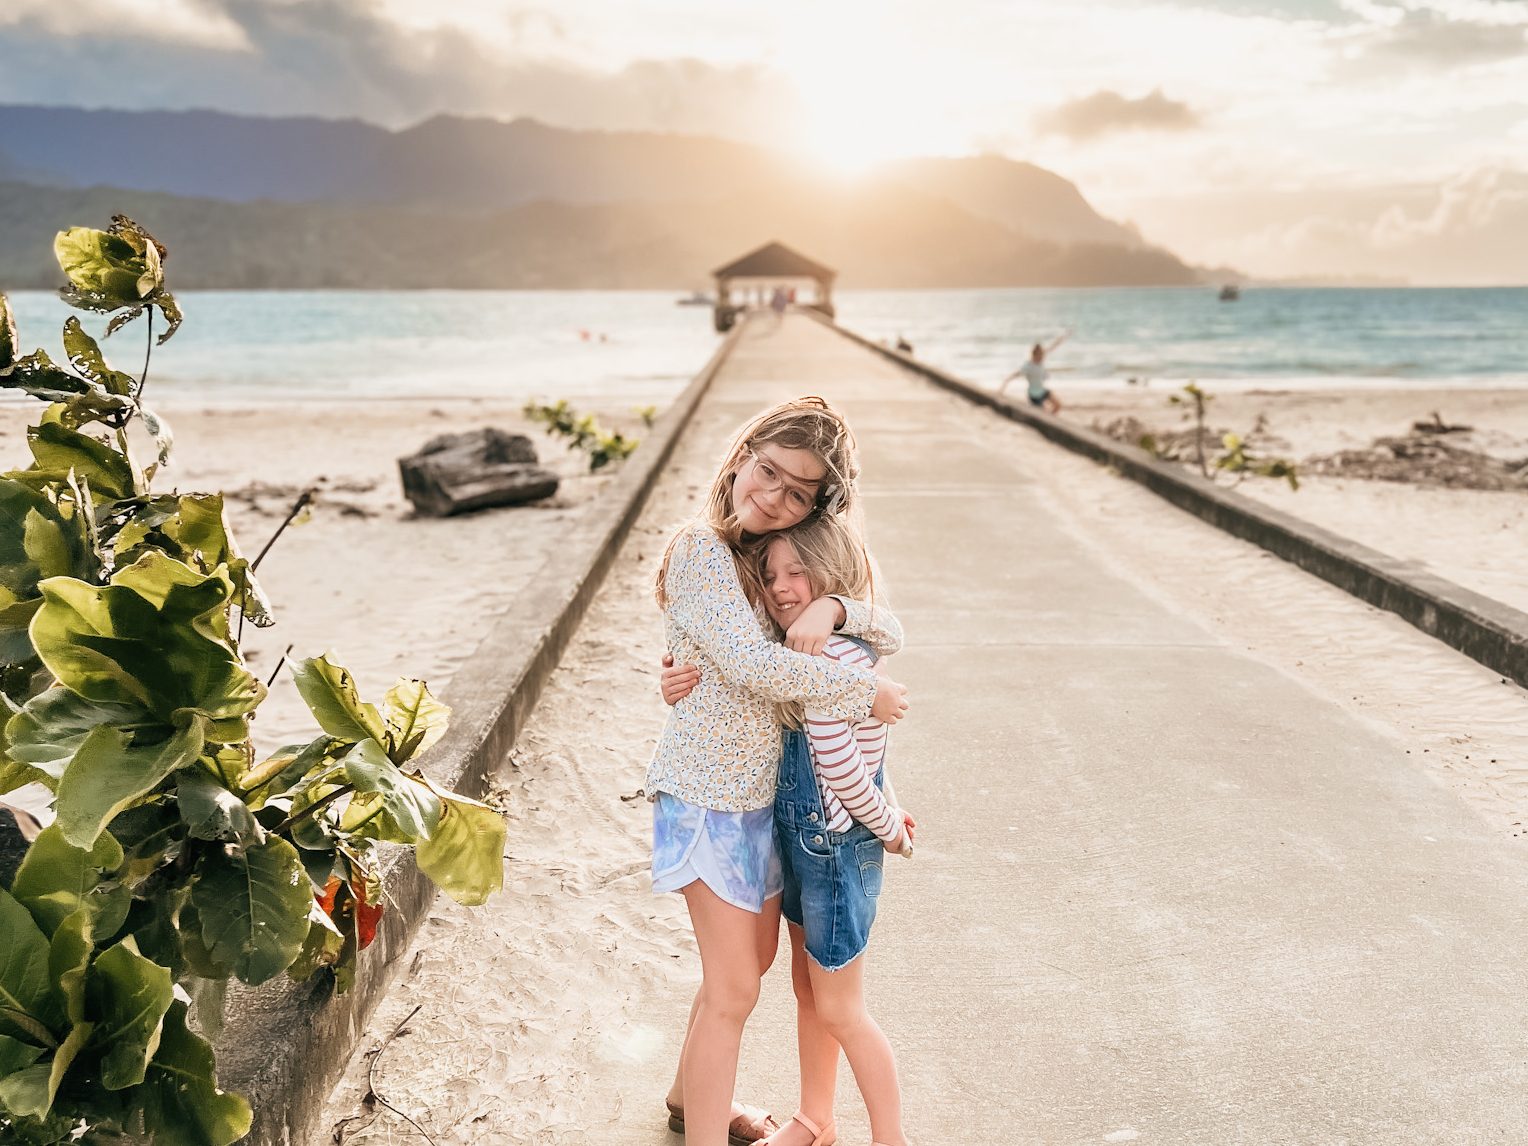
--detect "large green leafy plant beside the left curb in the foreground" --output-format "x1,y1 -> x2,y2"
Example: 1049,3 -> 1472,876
0,217 -> 504,1146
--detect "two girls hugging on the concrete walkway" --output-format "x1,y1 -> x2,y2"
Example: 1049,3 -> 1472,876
646,397 -> 915,1146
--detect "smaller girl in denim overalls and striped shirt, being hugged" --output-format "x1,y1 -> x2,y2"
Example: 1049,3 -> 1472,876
762,516 -> 915,1146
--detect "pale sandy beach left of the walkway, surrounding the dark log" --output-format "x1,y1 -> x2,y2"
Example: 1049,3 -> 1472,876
0,397 -> 643,764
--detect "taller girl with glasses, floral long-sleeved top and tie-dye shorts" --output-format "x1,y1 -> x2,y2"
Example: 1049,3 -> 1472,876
645,397 -> 908,1146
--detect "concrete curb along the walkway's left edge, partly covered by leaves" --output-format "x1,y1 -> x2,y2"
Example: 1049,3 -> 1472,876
217,322 -> 747,1146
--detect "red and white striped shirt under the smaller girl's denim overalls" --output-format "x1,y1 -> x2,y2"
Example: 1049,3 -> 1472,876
805,636 -> 902,843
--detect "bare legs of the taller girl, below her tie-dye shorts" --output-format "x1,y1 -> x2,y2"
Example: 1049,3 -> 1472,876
668,880 -> 781,1146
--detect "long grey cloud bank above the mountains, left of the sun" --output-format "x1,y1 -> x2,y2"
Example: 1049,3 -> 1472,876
0,0 -> 801,139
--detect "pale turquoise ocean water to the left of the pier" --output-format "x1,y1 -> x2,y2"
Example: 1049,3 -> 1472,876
9,290 -> 717,406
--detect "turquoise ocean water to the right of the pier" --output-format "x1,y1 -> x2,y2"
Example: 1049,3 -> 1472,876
836,287 -> 1528,388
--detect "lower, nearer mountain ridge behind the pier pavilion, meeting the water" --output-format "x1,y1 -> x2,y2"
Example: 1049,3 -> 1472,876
0,182 -> 1198,289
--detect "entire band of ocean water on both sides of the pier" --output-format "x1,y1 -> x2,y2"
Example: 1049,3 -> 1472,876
11,287 -> 1528,405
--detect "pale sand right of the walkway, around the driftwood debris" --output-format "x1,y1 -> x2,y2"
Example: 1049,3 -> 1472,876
1063,387 -> 1528,611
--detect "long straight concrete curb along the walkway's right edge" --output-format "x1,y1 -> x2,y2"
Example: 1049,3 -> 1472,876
814,316 -> 1528,688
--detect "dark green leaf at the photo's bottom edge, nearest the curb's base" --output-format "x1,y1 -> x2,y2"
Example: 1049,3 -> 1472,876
134,1001 -> 252,1146
